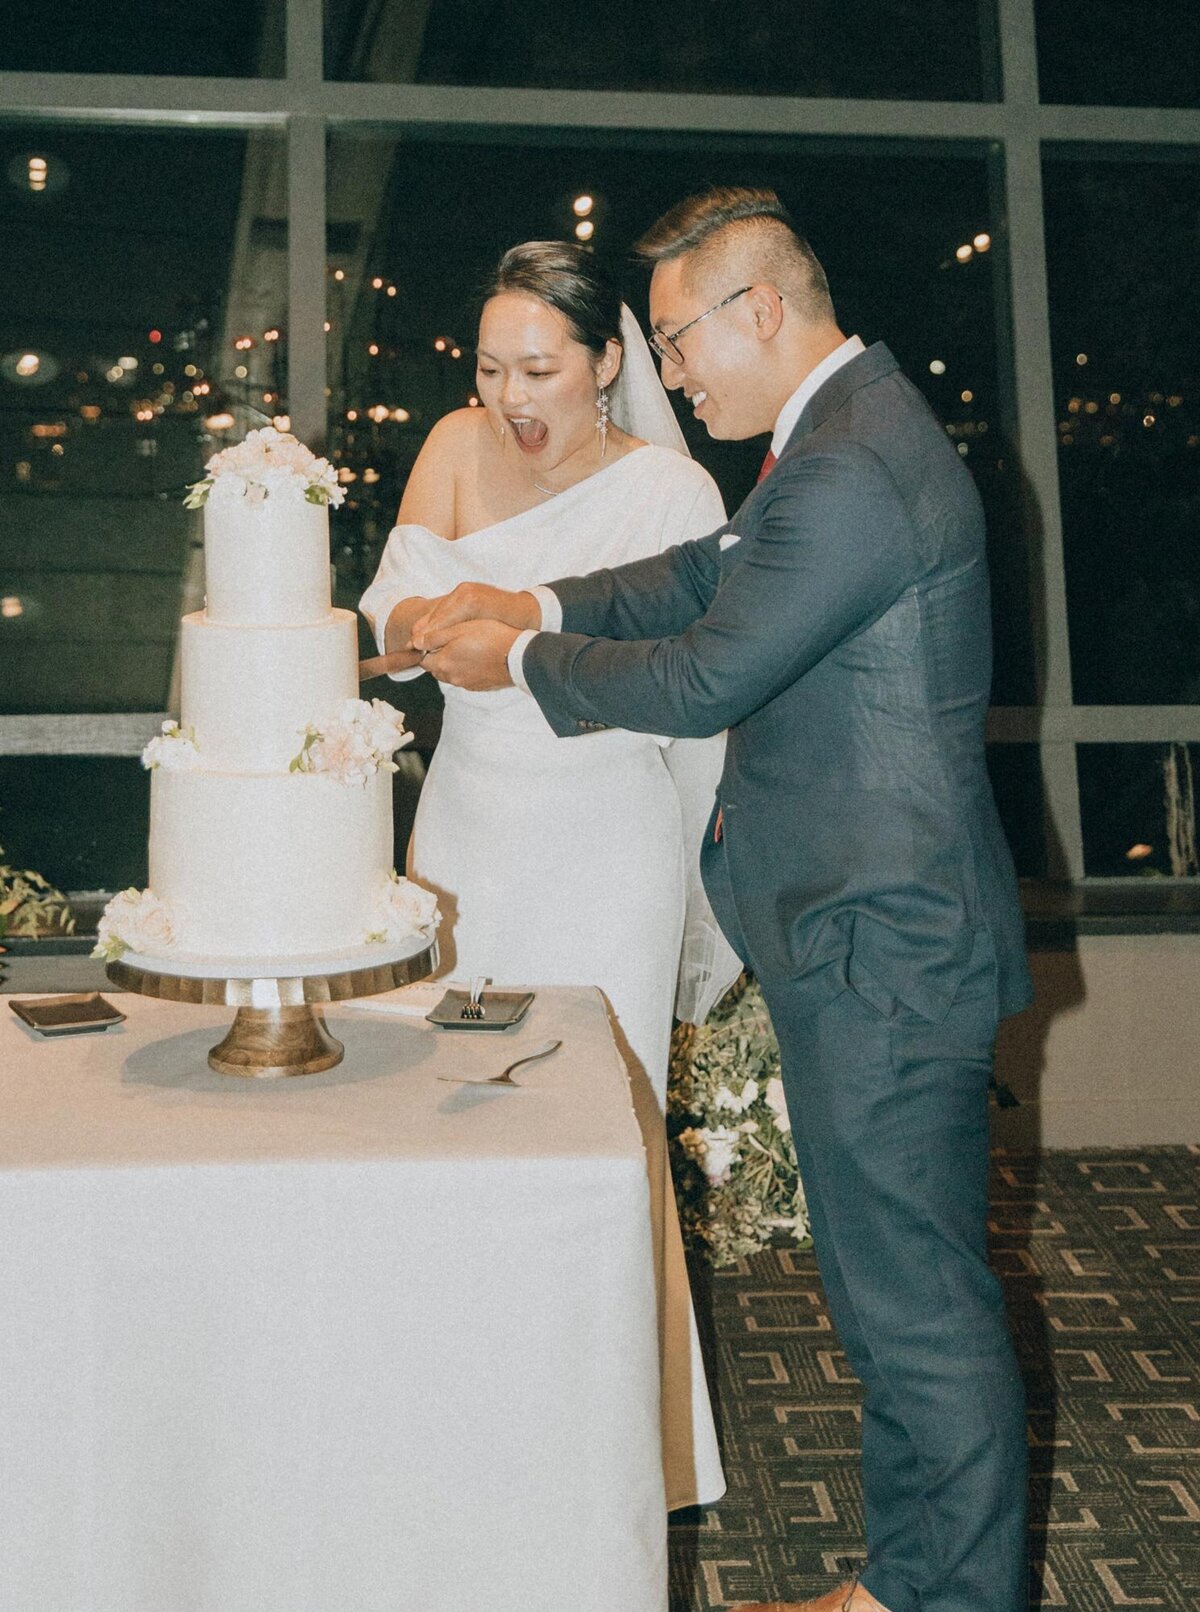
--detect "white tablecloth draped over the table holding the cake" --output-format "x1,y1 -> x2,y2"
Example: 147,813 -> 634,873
0,990 -> 693,1612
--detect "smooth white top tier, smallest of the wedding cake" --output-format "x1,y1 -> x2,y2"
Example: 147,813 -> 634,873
205,490 -> 331,627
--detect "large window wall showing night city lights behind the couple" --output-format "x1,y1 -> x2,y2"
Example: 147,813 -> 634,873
0,0 -> 1200,888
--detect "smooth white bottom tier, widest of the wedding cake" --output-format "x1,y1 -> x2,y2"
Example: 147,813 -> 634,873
150,767 -> 392,958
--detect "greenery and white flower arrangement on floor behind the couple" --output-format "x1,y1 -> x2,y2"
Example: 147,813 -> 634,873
666,975 -> 808,1265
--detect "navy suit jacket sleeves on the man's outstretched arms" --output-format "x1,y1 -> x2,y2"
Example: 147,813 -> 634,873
524,443 -> 931,738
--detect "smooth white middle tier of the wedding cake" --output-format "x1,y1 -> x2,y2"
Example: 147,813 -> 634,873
181,609 -> 358,772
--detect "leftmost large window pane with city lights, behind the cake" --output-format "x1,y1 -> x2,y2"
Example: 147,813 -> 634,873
0,126 -> 287,714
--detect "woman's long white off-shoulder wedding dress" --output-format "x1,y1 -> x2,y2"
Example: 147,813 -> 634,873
361,445 -> 739,1507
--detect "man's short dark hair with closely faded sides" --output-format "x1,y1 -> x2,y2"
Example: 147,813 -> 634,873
637,185 -> 834,324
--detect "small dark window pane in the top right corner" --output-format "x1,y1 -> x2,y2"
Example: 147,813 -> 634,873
1034,0 -> 1200,106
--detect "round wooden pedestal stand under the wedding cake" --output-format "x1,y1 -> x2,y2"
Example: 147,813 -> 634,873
105,933 -> 437,1080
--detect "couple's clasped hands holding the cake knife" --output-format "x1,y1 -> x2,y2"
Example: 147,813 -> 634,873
411,582 -> 542,690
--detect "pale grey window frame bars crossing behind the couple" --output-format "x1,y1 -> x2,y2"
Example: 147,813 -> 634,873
0,0 -> 1200,885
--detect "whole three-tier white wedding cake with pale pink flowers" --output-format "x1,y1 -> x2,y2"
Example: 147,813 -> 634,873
98,429 -> 437,967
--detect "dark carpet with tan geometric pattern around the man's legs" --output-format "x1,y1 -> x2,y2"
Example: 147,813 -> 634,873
671,1146 -> 1200,1612
